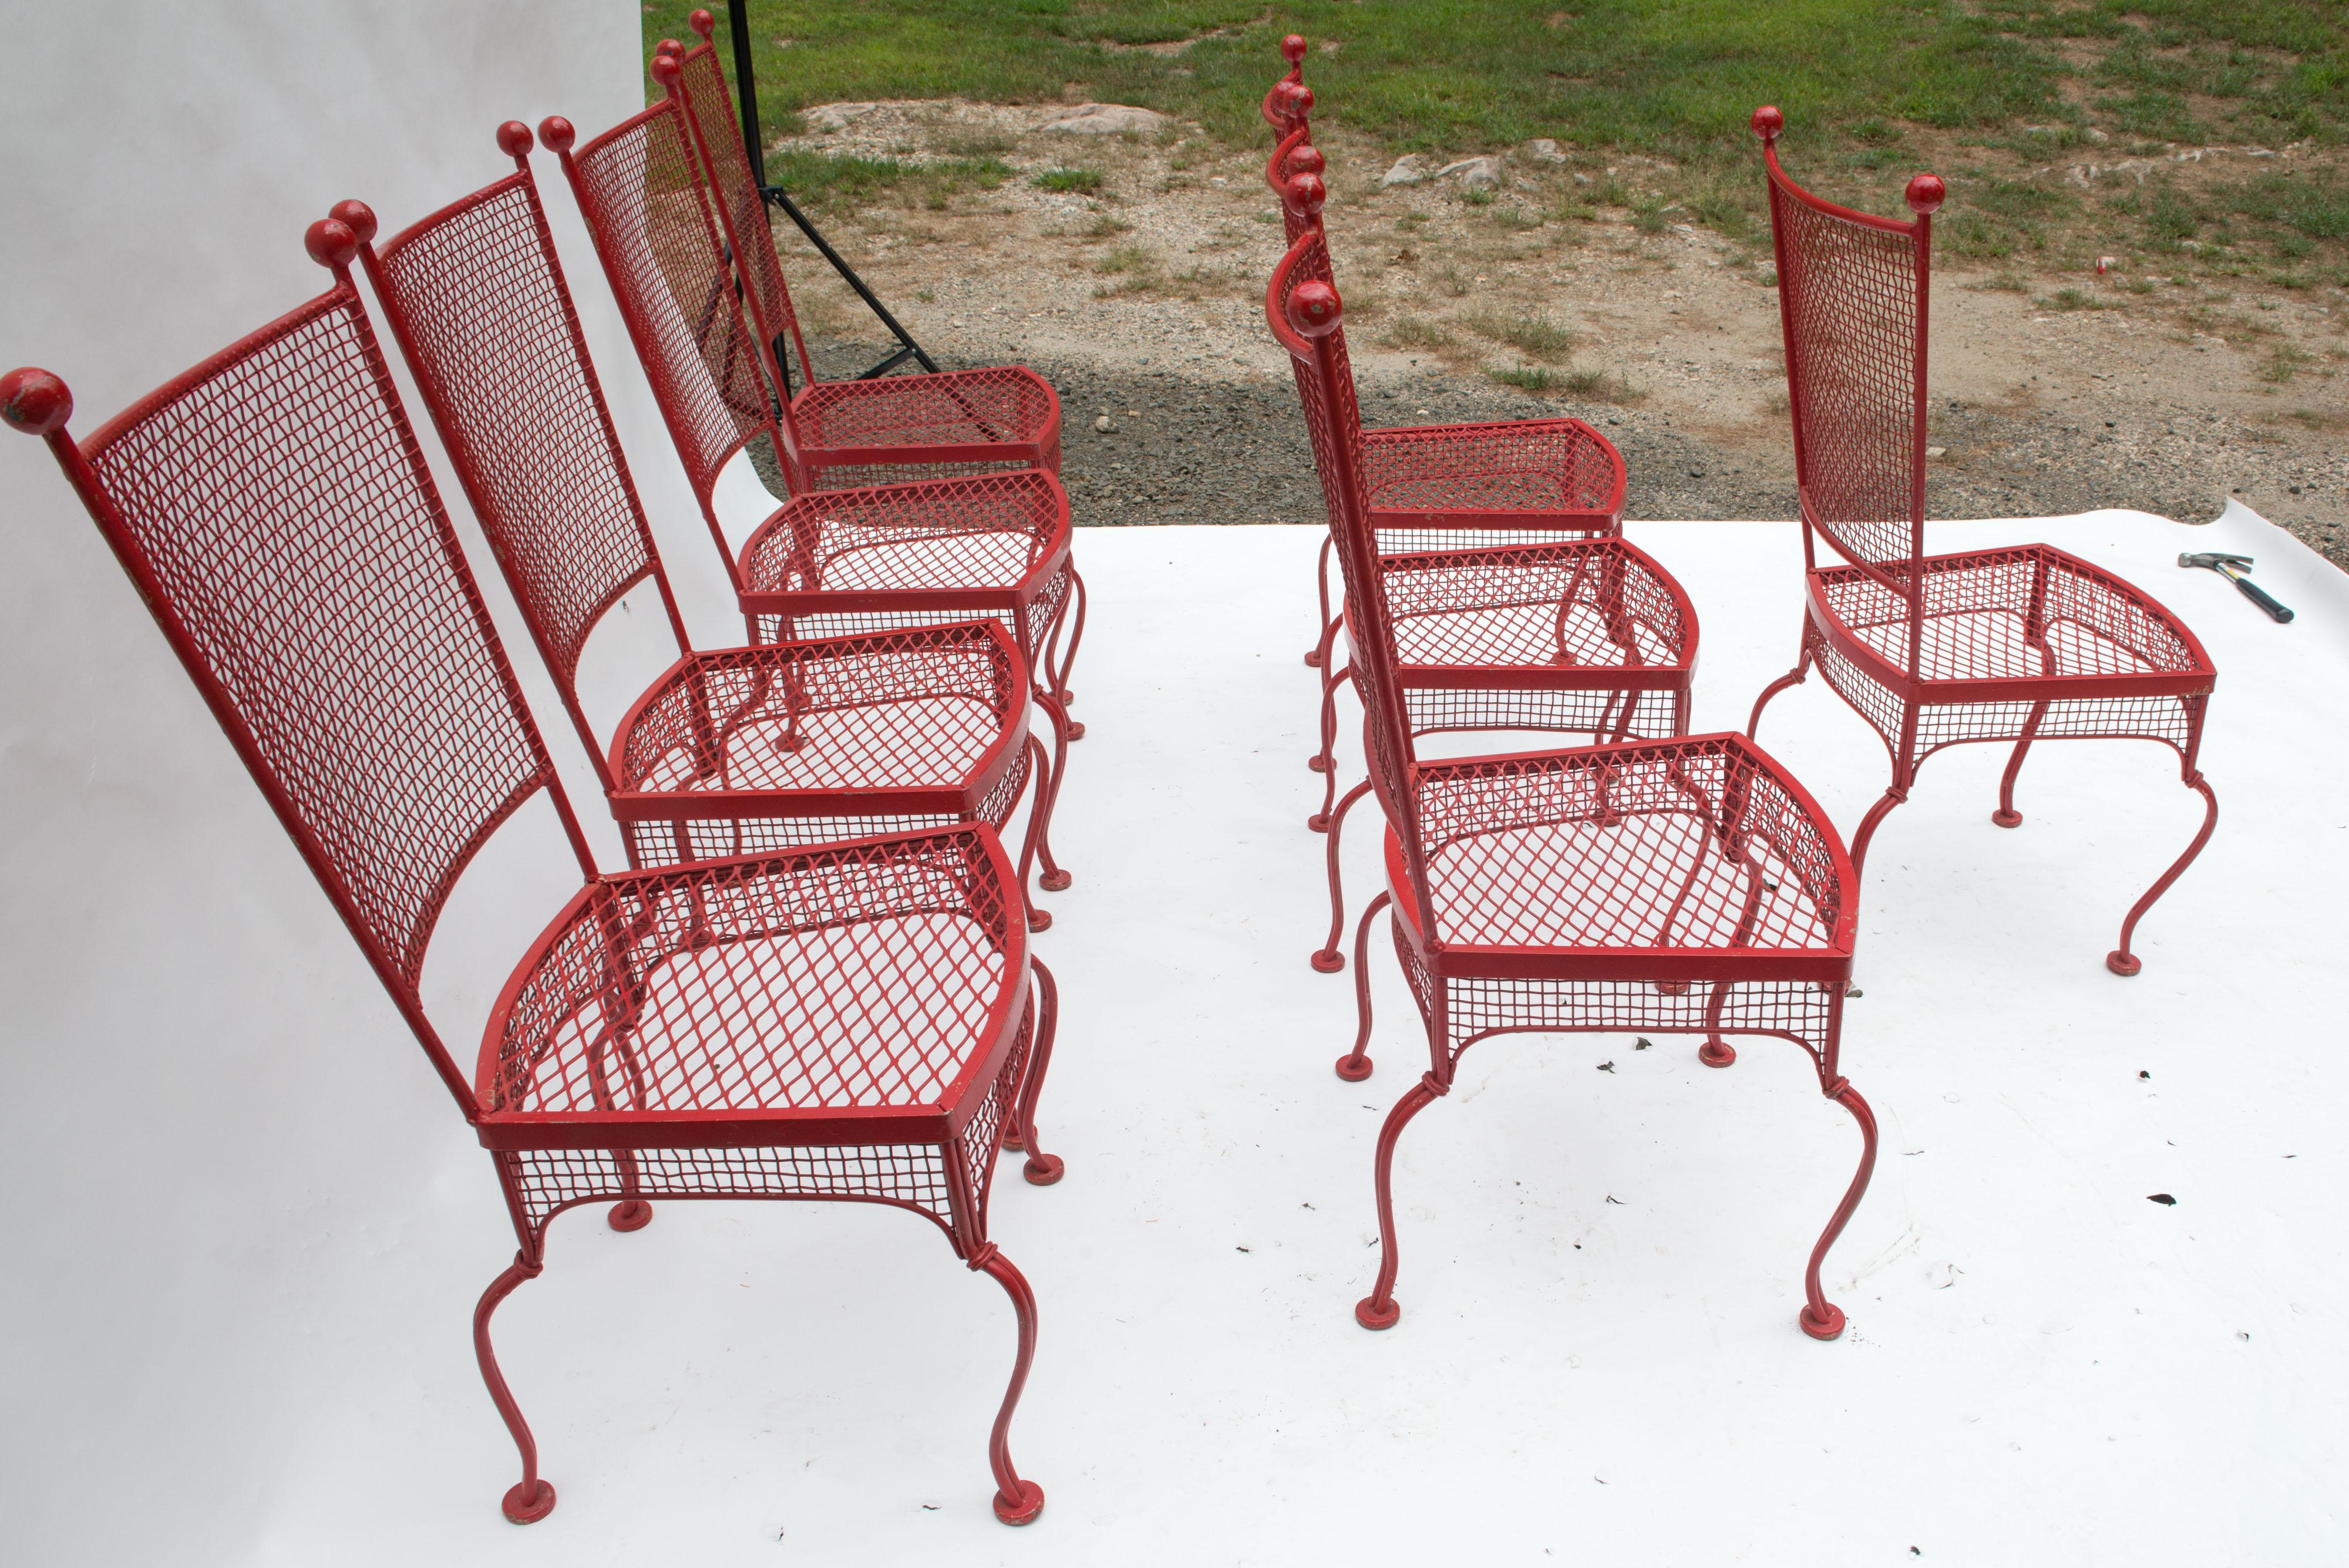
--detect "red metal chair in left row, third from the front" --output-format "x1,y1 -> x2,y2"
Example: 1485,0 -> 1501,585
538,99 -> 1085,892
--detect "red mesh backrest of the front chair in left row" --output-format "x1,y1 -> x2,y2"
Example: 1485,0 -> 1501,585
82,280 -> 559,1002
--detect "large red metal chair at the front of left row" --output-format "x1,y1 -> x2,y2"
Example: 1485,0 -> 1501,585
0,221 -> 1055,1523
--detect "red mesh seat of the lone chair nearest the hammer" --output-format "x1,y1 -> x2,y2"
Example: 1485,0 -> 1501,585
1818,544 -> 2210,681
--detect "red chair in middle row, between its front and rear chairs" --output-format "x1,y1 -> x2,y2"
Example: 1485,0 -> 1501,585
1283,177 -> 1698,974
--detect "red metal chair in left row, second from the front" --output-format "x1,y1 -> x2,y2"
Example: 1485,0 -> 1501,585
331,120 -> 1050,930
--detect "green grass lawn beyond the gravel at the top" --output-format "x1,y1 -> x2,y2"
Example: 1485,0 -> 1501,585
644,0 -> 2349,287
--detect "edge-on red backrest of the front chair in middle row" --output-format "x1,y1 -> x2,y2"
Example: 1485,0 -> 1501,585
1264,223 -> 1426,868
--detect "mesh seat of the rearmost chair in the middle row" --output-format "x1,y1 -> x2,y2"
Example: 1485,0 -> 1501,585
1362,420 -> 1623,528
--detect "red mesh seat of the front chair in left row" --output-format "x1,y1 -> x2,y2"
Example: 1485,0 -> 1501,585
479,829 -> 1017,1120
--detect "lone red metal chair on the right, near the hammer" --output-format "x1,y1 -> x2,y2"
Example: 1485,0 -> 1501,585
1745,108 -> 2217,974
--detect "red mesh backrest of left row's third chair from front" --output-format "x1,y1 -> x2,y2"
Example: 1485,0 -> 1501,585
564,99 -> 799,504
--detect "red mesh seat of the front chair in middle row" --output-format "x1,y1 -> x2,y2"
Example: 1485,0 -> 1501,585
1388,737 -> 1849,953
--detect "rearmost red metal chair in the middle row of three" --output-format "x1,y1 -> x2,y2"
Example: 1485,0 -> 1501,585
1261,33 -> 1626,676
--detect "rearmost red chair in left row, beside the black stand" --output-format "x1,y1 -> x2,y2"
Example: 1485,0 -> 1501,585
653,12 -> 1059,490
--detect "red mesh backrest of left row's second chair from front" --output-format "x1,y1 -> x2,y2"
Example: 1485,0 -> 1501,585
371,171 -> 660,704
